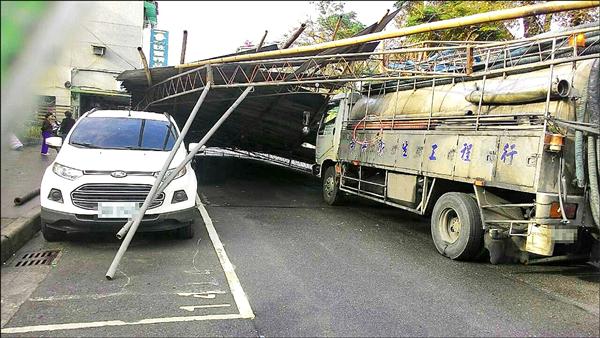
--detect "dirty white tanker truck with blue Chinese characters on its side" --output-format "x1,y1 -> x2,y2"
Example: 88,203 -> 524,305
313,26 -> 600,264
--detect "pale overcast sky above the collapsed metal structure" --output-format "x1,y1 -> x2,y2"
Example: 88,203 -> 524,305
143,1 -> 395,65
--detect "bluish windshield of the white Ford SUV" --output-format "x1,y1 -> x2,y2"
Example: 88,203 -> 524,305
69,117 -> 177,151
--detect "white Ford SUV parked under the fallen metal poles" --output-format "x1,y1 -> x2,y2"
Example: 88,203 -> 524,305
40,110 -> 198,241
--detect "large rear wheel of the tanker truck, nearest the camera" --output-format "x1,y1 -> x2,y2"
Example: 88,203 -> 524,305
431,192 -> 483,260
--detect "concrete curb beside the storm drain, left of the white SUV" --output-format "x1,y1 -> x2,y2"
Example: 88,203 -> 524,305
0,209 -> 40,263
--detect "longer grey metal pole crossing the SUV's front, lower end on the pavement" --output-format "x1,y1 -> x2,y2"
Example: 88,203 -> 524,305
106,82 -> 211,280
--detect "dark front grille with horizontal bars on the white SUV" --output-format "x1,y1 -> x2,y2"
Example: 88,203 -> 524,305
71,183 -> 165,210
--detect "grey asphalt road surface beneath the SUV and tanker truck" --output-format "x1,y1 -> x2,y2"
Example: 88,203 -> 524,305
2,159 -> 600,337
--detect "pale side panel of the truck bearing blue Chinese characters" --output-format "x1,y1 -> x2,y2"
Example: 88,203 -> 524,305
339,130 -> 543,192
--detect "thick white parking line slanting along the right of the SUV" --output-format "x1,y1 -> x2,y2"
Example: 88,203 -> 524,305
196,195 -> 254,319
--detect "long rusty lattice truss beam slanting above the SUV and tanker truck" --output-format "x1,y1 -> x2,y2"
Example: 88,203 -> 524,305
136,27 -> 599,110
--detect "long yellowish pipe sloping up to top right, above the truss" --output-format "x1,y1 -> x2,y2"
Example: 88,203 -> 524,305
175,1 -> 600,68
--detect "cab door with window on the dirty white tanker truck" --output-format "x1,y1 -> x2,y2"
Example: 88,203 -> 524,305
315,101 -> 340,164
